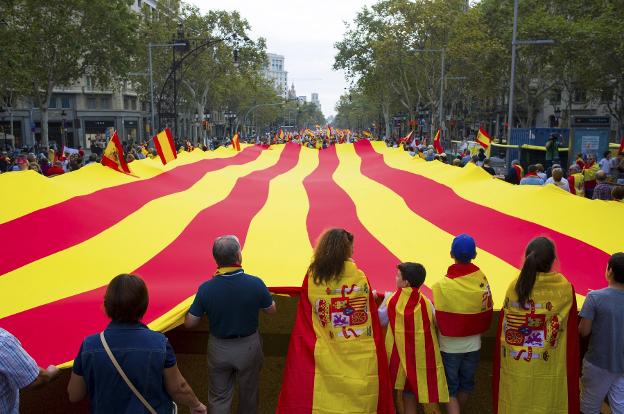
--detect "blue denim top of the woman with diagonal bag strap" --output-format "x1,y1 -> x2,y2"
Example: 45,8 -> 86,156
73,322 -> 176,414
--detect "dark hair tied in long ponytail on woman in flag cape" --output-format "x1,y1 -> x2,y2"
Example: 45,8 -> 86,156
515,237 -> 556,307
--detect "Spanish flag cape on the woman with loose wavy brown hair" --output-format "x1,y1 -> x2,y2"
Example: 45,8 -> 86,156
277,261 -> 395,414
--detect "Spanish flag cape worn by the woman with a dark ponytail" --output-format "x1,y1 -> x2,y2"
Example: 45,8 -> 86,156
492,273 -> 579,414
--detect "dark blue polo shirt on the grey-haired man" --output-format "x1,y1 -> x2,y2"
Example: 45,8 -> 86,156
189,269 -> 273,338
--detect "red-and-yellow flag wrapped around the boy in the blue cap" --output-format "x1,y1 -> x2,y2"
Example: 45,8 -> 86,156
433,263 -> 494,337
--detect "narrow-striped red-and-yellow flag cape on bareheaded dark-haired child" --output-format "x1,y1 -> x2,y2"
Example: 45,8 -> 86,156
386,288 -> 449,404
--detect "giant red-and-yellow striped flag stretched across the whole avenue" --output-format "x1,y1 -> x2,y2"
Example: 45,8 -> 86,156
0,141 -> 624,366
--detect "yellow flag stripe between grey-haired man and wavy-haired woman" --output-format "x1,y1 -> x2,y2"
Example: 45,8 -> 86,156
243,147 -> 319,286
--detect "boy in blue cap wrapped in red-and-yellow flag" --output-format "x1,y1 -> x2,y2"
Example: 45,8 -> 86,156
433,234 -> 493,414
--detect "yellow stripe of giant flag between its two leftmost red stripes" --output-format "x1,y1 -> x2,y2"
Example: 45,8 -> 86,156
0,147 -> 283,318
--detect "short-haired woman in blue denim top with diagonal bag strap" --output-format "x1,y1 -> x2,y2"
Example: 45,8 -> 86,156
67,274 -> 206,414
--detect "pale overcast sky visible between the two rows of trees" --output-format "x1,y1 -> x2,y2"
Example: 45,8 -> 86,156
194,0 -> 375,116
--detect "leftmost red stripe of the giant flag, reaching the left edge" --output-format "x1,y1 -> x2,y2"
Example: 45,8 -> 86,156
0,147 -> 262,277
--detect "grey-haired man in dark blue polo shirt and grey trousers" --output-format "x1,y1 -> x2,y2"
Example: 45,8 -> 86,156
184,236 -> 277,414
